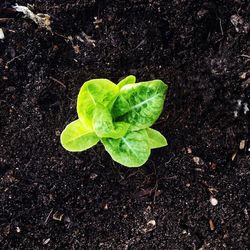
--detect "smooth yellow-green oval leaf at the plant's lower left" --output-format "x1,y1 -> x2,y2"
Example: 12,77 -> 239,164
61,119 -> 99,152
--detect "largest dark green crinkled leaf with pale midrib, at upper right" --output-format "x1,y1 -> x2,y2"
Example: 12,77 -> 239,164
112,80 -> 168,130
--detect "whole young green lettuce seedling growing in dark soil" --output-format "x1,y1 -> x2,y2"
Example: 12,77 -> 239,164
61,75 -> 168,167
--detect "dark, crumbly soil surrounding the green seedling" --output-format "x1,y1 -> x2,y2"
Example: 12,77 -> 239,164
0,0 -> 250,250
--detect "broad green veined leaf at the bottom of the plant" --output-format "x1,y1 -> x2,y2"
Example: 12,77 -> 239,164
102,129 -> 150,167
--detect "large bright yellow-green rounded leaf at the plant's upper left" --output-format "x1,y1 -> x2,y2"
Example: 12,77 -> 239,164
77,79 -> 119,129
